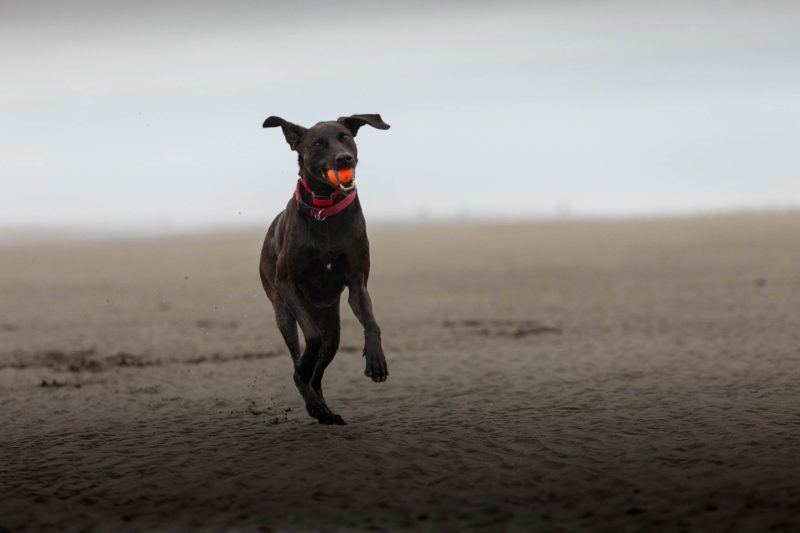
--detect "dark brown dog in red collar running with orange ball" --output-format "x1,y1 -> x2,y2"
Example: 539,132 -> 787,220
259,114 -> 389,424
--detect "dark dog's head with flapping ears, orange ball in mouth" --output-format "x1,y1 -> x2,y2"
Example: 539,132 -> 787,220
264,114 -> 389,192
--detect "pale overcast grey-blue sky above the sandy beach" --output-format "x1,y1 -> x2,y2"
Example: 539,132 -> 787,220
0,0 -> 800,231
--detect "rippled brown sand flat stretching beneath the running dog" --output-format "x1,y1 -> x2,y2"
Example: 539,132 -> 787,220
0,213 -> 800,531
